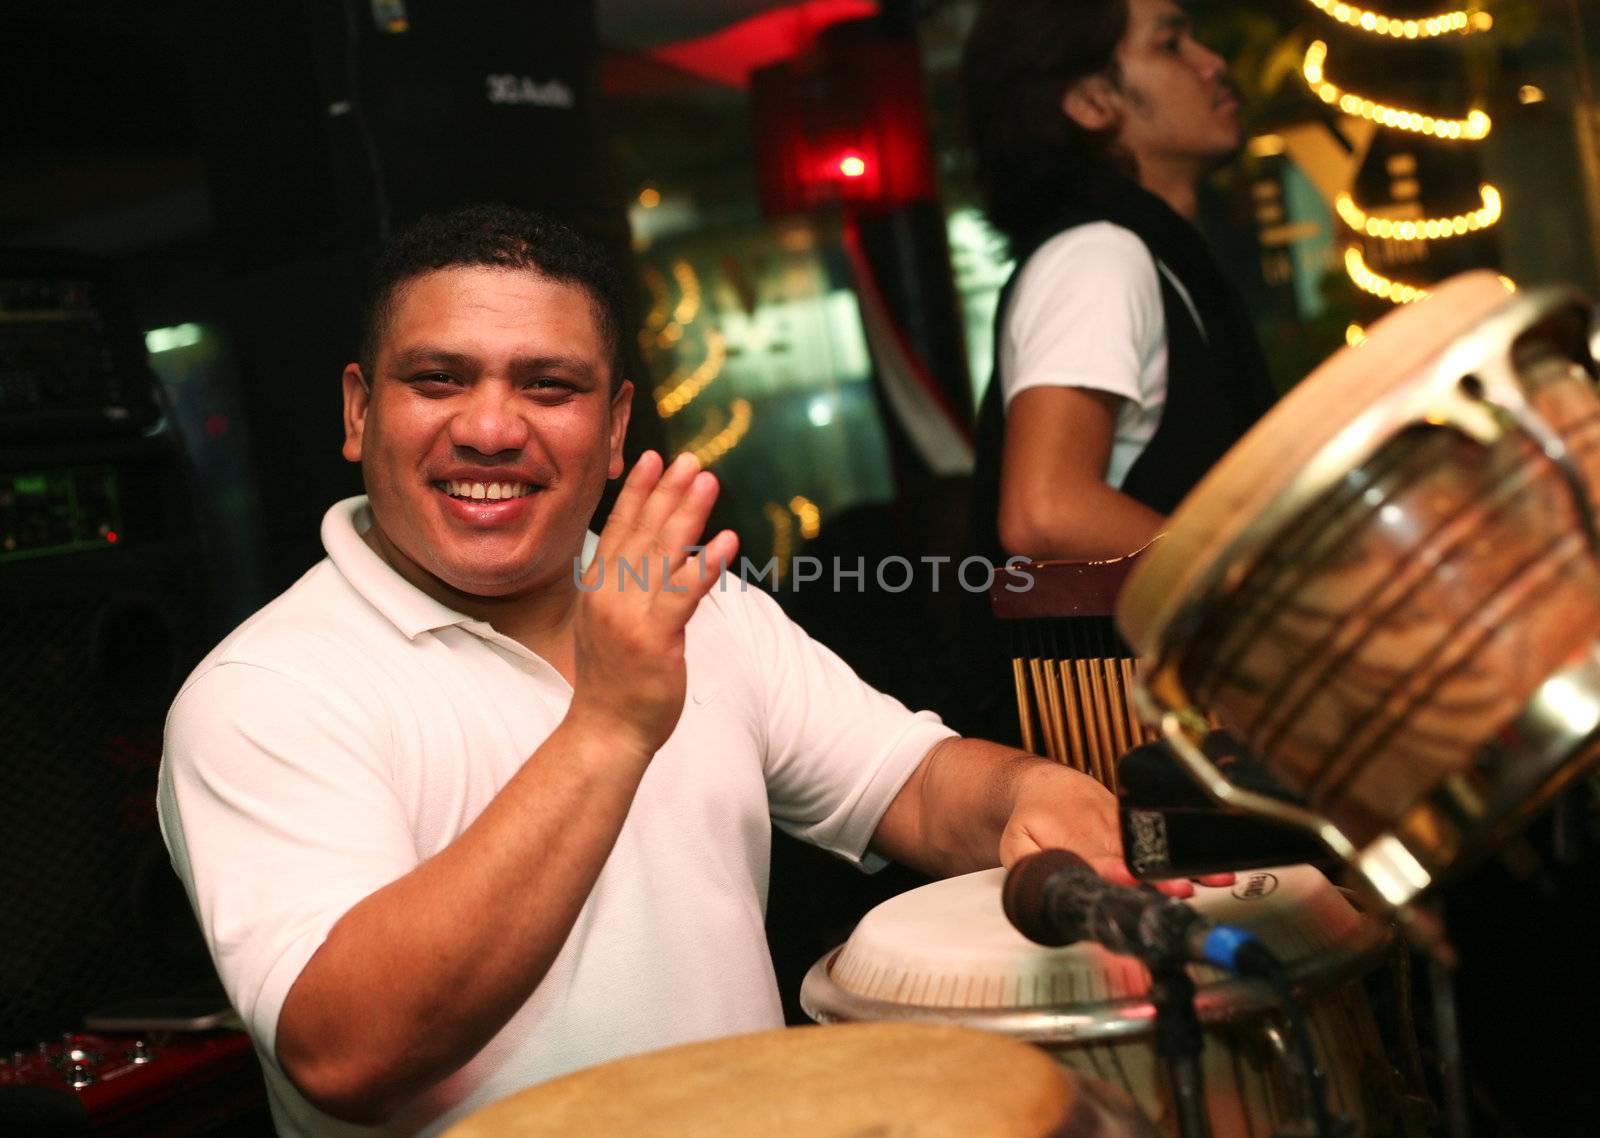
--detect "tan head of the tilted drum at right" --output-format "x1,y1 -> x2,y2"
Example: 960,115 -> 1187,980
1117,270 -> 1515,661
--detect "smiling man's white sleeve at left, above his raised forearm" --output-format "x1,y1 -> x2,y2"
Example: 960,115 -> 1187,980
157,663 -> 418,1056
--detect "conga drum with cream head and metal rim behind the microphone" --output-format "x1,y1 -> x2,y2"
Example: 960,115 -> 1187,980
800,866 -> 1398,1138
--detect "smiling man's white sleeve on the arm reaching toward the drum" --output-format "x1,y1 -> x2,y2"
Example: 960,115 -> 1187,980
710,578 -> 955,871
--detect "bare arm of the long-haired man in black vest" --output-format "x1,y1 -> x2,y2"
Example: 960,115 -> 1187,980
998,387 -> 1166,560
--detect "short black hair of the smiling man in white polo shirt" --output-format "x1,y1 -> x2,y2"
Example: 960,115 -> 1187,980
360,205 -> 624,391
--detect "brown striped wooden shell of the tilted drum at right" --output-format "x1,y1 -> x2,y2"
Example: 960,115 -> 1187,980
1179,344 -> 1600,845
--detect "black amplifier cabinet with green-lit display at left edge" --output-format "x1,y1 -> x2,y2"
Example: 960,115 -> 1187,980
0,434 -> 218,1047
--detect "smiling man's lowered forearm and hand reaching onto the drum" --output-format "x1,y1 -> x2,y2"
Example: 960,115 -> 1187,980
872,739 -> 1203,896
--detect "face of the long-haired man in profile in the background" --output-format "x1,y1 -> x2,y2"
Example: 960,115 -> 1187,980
1115,0 -> 1240,168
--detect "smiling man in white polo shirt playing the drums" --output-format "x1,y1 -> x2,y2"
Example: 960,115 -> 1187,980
160,208 -> 1184,1135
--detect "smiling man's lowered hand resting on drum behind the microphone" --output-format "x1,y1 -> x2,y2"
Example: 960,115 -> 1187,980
1000,760 -> 1234,896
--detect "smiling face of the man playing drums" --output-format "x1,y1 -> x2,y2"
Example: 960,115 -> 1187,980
344,267 -> 632,603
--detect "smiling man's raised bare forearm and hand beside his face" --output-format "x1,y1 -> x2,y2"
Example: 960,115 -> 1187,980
277,455 -> 738,1122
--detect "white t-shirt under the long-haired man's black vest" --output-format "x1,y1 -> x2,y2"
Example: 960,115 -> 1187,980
998,221 -> 1200,488
